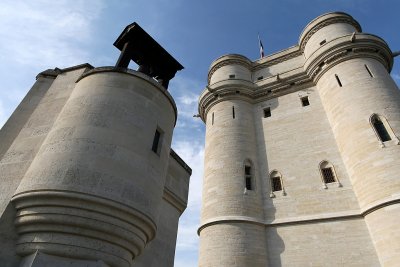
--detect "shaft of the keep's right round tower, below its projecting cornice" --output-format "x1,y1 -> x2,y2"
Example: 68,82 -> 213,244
318,58 -> 400,266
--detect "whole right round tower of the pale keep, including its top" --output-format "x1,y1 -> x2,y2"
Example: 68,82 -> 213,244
300,13 -> 400,266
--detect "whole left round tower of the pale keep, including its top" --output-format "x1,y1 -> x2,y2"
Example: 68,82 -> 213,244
198,55 -> 267,267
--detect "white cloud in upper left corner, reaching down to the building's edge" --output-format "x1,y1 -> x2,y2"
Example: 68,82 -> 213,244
0,0 -> 105,129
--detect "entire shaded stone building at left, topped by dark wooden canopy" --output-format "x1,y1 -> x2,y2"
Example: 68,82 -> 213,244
0,23 -> 191,267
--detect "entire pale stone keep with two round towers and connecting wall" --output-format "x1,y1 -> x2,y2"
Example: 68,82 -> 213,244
198,12 -> 400,267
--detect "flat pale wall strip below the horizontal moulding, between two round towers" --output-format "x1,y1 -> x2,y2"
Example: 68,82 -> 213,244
266,218 -> 380,267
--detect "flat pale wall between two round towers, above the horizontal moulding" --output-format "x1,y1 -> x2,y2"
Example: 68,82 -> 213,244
254,87 -> 359,222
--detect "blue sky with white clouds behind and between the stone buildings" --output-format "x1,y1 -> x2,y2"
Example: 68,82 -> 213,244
0,0 -> 400,267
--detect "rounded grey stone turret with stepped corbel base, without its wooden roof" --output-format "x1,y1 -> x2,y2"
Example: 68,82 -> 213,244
13,67 -> 176,267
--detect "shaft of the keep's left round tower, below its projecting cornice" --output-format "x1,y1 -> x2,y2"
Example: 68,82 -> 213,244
199,99 -> 267,267
